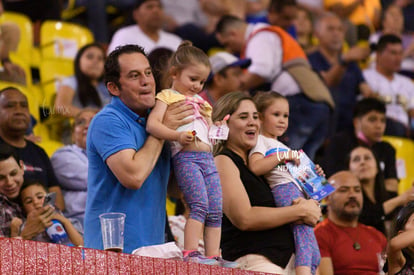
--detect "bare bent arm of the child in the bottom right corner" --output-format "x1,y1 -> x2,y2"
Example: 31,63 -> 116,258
387,229 -> 414,274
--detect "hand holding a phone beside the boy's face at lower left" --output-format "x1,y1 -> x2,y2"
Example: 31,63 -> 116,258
21,205 -> 55,240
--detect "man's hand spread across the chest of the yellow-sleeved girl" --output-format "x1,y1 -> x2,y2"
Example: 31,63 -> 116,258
162,100 -> 194,130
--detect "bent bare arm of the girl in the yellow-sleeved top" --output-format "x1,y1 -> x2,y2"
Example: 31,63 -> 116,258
147,100 -> 193,145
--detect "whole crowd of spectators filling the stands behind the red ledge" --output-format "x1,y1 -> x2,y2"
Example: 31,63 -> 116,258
0,0 -> 414,275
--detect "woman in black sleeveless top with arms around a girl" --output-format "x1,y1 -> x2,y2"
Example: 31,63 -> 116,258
212,92 -> 321,274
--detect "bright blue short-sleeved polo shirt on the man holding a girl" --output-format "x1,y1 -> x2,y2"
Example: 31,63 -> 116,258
84,97 -> 170,253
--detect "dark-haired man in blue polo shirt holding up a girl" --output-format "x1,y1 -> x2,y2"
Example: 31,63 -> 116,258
84,45 -> 192,253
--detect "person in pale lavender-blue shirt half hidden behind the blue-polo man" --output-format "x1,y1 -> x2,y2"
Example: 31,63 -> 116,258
51,109 -> 97,227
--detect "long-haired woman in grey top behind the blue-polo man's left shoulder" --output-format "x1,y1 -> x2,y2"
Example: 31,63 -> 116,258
55,44 -> 111,118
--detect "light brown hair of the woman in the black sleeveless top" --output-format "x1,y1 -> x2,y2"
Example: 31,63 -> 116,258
211,92 -> 254,156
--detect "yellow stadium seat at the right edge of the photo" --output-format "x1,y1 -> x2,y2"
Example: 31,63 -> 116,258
384,136 -> 414,194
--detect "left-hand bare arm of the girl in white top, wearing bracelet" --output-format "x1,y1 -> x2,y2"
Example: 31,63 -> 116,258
249,150 -> 299,176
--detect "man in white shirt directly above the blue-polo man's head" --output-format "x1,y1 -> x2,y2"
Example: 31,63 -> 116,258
108,0 -> 181,54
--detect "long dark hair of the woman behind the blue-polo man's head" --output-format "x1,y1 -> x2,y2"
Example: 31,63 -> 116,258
74,43 -> 105,107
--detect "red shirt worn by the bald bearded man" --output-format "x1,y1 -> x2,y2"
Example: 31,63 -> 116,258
315,219 -> 387,275
